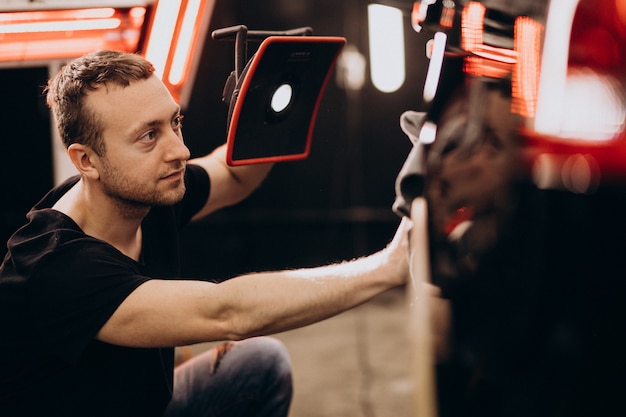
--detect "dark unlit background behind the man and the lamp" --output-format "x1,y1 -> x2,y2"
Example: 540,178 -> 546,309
0,0 -> 426,279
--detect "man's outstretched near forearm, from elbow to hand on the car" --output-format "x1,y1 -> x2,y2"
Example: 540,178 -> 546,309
212,218 -> 409,339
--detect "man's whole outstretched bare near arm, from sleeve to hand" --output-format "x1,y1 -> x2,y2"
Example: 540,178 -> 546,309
97,219 -> 410,347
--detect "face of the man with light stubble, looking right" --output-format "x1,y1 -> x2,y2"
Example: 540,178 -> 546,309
86,75 -> 190,206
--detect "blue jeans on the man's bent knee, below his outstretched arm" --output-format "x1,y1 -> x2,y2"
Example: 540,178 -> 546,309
163,337 -> 292,417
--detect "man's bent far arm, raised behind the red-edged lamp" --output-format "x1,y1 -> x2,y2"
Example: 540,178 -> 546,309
189,145 -> 272,220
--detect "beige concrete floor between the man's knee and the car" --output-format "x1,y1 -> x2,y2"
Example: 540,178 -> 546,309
276,288 -> 413,417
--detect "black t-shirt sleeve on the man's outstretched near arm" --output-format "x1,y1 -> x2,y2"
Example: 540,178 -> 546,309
30,240 -> 150,363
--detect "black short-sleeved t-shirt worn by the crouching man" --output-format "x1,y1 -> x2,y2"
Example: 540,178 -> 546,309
0,165 -> 210,417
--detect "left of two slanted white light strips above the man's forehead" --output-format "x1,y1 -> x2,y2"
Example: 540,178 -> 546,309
145,0 -> 182,78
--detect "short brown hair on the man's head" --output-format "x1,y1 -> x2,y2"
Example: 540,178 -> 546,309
45,50 -> 154,155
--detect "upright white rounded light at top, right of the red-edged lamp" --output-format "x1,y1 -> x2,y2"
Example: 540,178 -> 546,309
367,4 -> 405,93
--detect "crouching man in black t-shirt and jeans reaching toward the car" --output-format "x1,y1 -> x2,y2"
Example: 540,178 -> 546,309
0,51 -> 408,417
